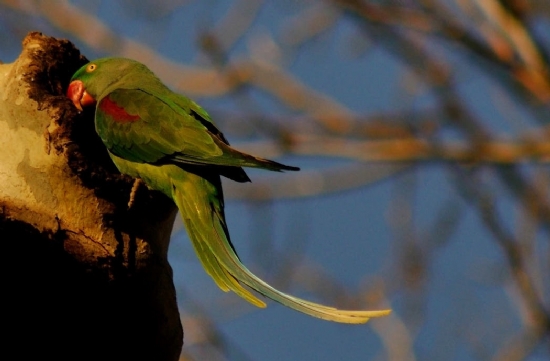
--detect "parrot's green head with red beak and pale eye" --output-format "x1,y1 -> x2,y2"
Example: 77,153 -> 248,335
67,58 -> 152,111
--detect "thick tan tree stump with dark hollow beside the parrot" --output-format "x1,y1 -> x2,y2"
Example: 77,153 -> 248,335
0,33 -> 183,360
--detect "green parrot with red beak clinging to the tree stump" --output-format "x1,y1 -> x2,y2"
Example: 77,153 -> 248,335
67,58 -> 390,323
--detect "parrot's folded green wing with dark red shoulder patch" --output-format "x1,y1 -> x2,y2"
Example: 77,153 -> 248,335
96,89 -> 298,174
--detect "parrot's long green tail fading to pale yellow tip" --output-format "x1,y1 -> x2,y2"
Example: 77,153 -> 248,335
172,170 -> 391,323
